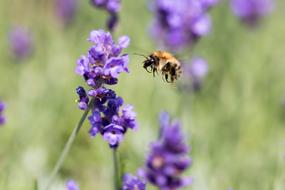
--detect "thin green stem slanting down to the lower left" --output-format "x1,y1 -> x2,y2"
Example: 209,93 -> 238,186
46,99 -> 94,190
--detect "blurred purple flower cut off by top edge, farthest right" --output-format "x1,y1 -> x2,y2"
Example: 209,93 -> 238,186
231,0 -> 273,26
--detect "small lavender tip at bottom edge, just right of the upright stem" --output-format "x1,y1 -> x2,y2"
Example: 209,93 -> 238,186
122,174 -> 146,190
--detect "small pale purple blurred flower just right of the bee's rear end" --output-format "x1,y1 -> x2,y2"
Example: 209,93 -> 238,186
180,57 -> 209,91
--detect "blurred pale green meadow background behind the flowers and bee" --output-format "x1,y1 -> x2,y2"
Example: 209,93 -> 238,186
0,0 -> 285,190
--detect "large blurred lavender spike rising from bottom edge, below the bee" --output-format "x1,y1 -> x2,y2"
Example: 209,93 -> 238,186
145,113 -> 192,190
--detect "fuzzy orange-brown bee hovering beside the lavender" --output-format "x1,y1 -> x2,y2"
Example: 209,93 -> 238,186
136,50 -> 182,83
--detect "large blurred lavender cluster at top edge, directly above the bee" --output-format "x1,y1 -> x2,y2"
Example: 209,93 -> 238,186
152,0 -> 217,51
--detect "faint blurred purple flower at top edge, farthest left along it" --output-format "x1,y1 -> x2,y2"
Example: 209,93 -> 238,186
55,0 -> 77,25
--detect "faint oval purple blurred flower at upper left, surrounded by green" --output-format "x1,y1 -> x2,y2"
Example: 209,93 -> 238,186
9,27 -> 33,60
